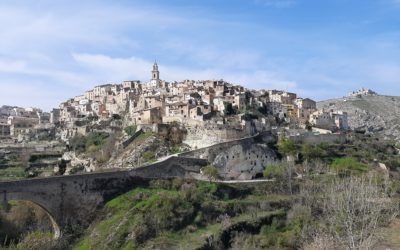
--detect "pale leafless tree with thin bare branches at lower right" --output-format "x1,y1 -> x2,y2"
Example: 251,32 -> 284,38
322,176 -> 398,249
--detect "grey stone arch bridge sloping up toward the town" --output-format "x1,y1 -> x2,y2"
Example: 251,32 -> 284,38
0,156 -> 207,237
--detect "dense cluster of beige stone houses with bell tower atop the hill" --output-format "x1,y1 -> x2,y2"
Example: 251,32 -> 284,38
0,63 -> 347,141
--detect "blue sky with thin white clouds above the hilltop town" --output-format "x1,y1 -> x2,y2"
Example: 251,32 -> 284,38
0,0 -> 400,110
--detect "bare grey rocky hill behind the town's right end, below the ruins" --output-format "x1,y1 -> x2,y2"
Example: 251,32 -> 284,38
317,95 -> 400,141
